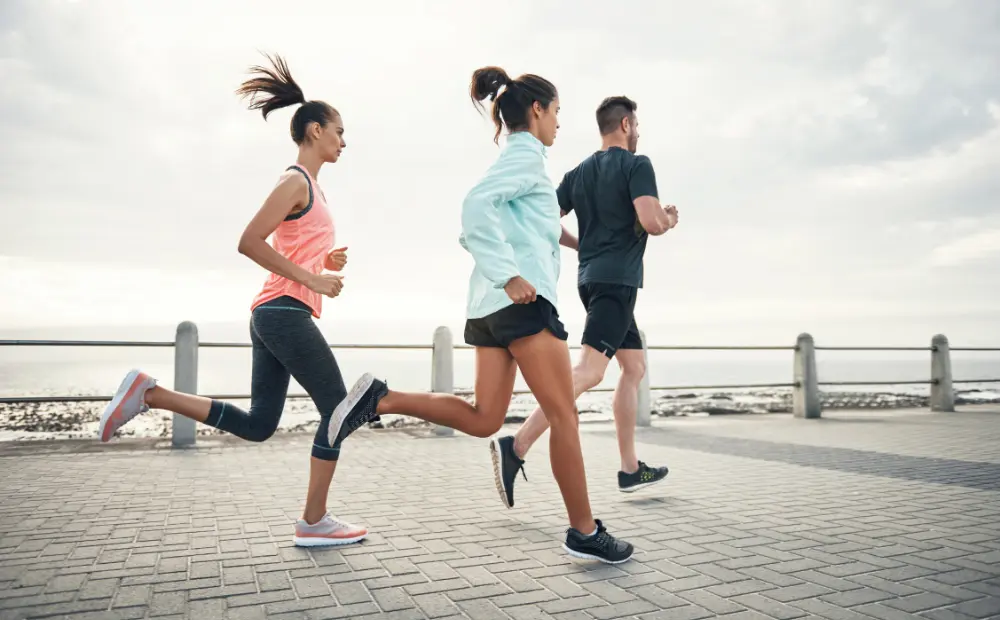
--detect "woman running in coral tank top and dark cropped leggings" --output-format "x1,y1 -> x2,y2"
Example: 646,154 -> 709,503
98,57 -> 368,546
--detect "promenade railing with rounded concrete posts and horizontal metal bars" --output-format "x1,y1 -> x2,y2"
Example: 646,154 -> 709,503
0,330 -> 1000,447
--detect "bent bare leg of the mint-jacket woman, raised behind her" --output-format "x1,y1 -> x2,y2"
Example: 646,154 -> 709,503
378,347 -> 517,437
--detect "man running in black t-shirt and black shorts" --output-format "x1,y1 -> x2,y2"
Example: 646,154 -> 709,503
490,97 -> 677,507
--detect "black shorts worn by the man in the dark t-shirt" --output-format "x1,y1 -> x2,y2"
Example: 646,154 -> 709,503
579,282 -> 642,358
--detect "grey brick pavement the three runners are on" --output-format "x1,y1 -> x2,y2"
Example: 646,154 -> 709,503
0,408 -> 1000,620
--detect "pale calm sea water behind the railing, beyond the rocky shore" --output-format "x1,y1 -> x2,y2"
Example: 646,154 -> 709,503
0,347 -> 1000,396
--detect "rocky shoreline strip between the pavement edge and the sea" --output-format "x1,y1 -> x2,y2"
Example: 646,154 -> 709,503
0,390 -> 1000,441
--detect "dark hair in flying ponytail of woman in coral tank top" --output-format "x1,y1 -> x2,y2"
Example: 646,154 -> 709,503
236,54 -> 340,144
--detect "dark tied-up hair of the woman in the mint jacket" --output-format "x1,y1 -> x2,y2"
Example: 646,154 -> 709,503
469,67 -> 559,142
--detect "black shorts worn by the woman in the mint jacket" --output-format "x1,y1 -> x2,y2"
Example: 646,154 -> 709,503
465,297 -> 569,349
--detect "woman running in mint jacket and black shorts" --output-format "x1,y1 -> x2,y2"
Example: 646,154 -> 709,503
330,67 -> 633,563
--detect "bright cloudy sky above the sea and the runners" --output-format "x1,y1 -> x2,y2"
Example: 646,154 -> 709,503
0,0 -> 1000,344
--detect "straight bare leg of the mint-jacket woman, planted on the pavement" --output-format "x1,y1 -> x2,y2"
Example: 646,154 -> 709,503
510,330 -> 597,535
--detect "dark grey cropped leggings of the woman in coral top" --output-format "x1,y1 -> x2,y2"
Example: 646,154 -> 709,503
205,297 -> 347,461
